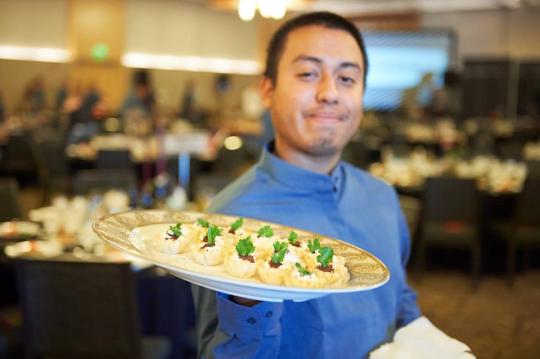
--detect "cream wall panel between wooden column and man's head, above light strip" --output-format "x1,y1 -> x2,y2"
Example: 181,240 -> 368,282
125,0 -> 257,60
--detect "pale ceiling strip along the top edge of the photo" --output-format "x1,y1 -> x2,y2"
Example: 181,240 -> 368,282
201,0 -> 540,15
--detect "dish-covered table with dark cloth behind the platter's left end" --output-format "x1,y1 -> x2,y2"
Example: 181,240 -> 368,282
0,191 -> 194,357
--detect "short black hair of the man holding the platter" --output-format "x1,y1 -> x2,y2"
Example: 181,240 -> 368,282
264,11 -> 368,87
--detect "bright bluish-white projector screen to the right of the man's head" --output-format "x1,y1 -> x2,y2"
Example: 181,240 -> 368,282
362,30 -> 455,111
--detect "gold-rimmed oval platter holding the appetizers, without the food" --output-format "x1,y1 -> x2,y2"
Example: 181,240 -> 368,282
93,210 -> 390,301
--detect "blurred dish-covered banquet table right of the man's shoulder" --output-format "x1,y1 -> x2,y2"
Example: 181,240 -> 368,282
369,149 -> 528,271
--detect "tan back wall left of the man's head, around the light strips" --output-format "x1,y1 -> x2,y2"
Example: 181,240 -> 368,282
0,0 -> 266,112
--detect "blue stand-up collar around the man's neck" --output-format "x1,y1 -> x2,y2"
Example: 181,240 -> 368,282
259,142 -> 345,192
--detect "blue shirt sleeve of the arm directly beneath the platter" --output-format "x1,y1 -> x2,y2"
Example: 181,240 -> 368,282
192,285 -> 283,358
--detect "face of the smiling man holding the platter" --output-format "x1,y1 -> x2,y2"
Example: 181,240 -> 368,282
262,26 -> 364,158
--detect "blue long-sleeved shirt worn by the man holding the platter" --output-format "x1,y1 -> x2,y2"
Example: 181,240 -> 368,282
193,145 -> 420,358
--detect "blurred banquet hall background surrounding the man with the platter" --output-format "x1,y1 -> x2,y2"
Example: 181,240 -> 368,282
0,0 -> 540,359
